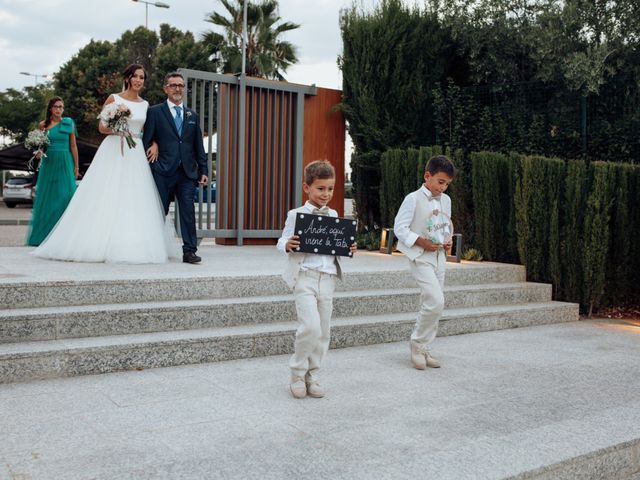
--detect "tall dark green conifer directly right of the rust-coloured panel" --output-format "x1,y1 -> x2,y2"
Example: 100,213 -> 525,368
338,0 -> 453,153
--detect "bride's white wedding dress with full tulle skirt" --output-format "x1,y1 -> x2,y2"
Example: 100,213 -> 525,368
32,94 -> 182,263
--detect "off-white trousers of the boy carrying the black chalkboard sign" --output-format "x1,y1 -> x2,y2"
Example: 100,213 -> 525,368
289,270 -> 336,378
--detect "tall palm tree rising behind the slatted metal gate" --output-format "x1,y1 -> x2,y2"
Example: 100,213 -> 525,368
202,0 -> 300,80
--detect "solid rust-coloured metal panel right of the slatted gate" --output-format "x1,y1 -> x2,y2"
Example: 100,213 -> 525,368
303,88 -> 345,216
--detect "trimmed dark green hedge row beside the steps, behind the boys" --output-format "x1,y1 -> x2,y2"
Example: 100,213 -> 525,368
380,147 -> 640,314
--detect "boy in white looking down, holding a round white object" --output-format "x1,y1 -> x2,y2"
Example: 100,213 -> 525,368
393,155 -> 455,370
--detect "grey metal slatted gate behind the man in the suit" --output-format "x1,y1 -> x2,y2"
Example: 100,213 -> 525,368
180,69 -> 316,245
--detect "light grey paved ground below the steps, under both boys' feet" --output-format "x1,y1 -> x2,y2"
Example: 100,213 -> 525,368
0,320 -> 640,480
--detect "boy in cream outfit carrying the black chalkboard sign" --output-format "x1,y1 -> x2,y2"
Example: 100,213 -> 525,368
278,160 -> 356,398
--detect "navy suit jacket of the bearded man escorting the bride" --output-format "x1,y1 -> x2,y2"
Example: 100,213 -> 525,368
142,101 -> 209,180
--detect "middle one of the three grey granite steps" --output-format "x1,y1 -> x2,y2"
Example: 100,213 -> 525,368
0,282 -> 551,343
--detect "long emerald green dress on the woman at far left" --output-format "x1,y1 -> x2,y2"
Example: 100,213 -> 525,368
27,117 -> 77,246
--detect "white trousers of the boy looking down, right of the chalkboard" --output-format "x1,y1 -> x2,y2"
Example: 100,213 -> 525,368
409,249 -> 447,345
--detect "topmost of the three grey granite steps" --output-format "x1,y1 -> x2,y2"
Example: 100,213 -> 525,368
0,255 -> 525,310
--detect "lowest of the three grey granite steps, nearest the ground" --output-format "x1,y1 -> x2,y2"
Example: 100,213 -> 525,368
0,302 -> 578,383
